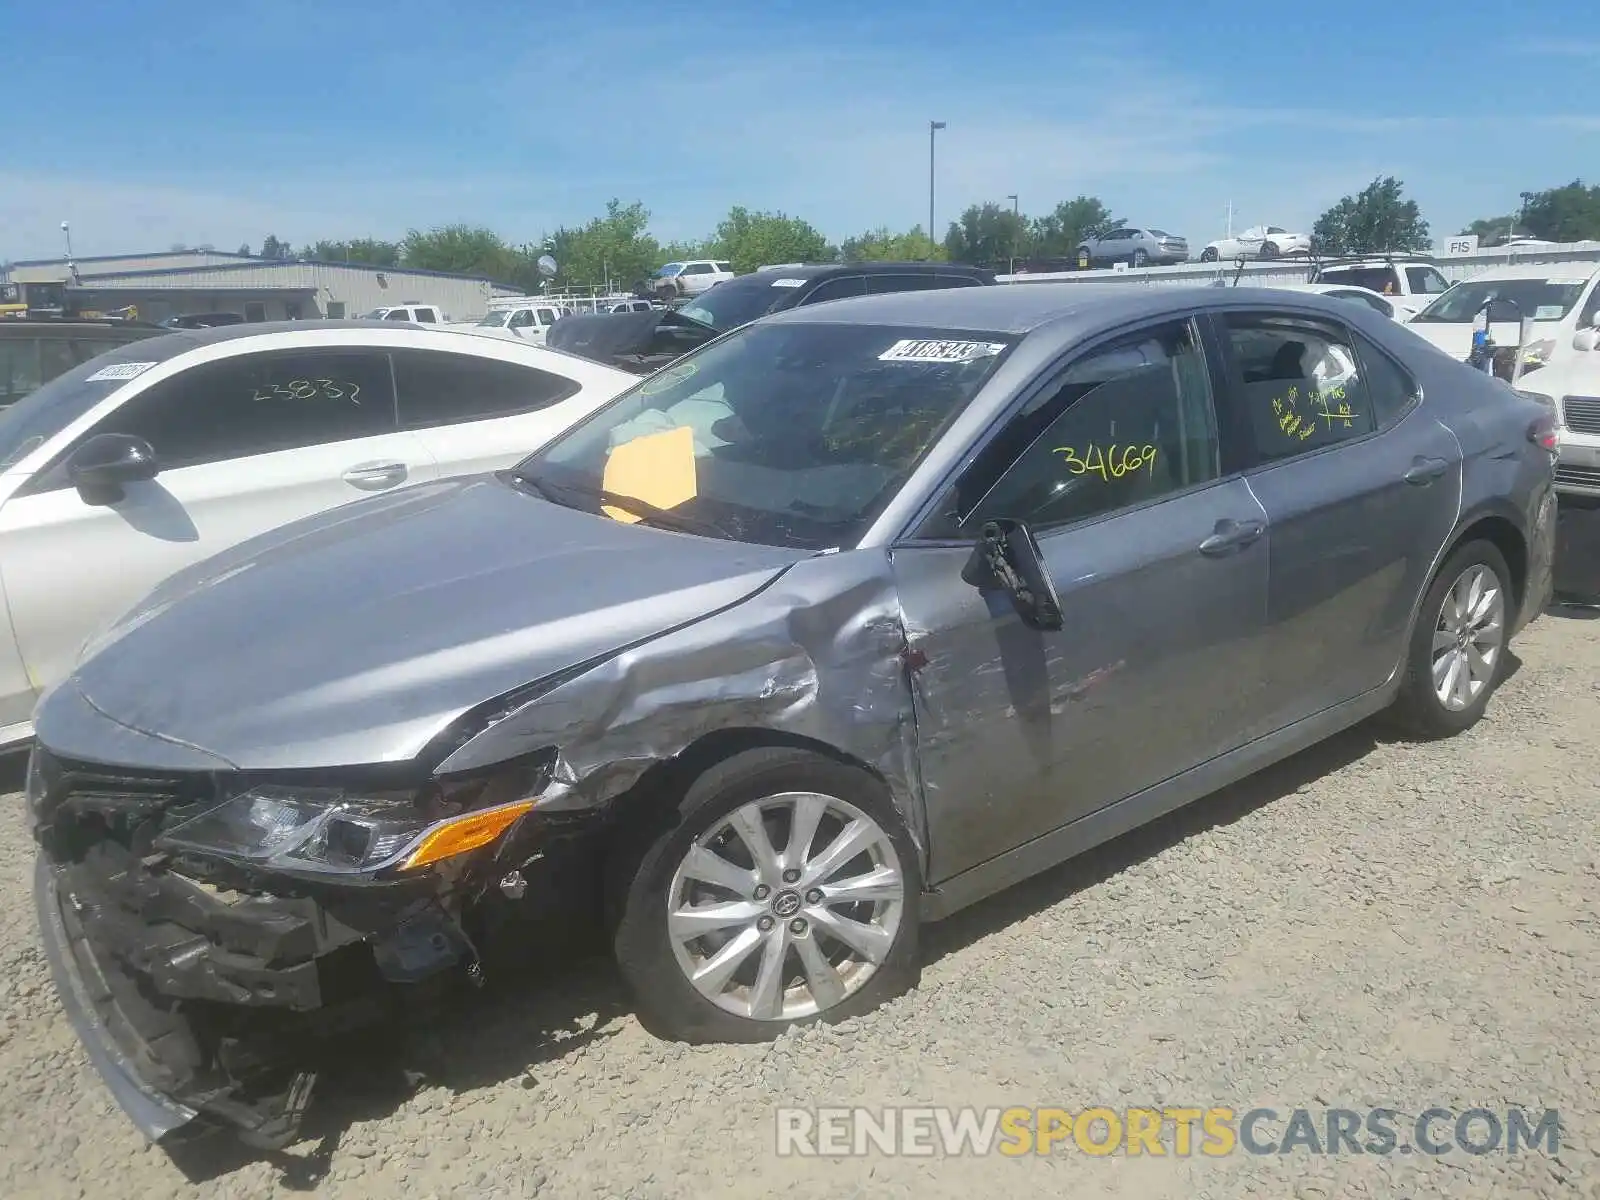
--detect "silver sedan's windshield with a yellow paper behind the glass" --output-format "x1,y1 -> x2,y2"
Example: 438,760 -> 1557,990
515,323 -> 1014,550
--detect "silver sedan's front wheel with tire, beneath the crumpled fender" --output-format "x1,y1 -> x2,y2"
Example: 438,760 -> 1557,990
613,747 -> 922,1042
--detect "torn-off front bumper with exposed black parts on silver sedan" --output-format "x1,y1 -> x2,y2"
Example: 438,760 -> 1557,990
29,752 -> 482,1149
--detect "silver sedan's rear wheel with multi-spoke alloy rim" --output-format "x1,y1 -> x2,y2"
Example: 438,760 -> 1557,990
1392,541 -> 1515,739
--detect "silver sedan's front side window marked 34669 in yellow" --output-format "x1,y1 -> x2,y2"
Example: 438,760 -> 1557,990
923,322 -> 1221,538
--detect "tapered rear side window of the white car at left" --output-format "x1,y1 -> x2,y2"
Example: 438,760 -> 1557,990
394,350 -> 582,429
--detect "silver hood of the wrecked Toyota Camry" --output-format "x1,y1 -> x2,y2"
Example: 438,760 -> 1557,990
35,475 -> 806,770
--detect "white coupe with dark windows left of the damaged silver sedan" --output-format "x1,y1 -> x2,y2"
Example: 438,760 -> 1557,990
0,322 -> 638,747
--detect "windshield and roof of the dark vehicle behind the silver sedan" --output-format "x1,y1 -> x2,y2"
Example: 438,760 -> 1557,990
678,262 -> 995,333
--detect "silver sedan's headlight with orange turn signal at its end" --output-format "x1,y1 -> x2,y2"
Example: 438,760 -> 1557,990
154,771 -> 534,875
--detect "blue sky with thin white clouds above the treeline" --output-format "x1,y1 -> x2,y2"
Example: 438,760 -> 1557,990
0,0 -> 1600,259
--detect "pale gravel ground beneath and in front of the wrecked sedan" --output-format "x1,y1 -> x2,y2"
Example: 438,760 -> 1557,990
0,610 -> 1600,1200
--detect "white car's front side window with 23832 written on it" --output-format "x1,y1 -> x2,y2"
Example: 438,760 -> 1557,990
84,350 -> 395,470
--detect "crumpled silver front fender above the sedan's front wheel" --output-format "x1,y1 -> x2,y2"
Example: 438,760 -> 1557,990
437,549 -> 926,859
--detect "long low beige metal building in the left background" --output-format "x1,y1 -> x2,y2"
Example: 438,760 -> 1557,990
8,250 -> 520,322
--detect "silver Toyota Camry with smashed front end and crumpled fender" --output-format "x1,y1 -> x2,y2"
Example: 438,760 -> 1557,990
27,285 -> 1557,1146
